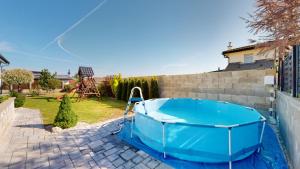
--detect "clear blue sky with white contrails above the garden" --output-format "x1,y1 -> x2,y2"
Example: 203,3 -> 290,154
0,0 -> 255,76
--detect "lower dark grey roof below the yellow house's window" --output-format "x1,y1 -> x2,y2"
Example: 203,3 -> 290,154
223,59 -> 274,71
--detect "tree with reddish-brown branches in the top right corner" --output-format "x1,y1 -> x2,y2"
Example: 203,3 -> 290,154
243,0 -> 300,56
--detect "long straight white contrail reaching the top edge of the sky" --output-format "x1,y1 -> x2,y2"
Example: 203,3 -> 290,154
40,0 -> 107,51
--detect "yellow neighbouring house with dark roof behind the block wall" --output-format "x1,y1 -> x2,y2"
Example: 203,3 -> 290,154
222,42 -> 276,71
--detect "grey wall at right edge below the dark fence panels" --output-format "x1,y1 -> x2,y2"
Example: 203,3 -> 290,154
276,92 -> 300,168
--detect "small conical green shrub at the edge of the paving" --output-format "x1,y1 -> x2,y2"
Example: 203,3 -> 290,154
54,95 -> 78,129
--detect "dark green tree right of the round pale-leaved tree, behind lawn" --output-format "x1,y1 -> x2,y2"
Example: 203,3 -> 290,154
39,69 -> 57,92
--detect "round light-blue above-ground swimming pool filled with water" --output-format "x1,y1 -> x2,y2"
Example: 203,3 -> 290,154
131,98 -> 265,165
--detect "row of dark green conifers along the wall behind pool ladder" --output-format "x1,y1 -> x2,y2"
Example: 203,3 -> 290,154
117,78 -> 159,101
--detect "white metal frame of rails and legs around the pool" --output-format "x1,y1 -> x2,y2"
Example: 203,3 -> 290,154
130,100 -> 266,169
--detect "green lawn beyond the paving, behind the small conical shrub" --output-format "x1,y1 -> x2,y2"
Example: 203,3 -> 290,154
23,96 -> 126,125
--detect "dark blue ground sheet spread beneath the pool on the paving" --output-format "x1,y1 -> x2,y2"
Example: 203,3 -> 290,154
118,122 -> 288,169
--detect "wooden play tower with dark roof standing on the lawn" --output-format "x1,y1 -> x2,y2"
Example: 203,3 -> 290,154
76,66 -> 101,101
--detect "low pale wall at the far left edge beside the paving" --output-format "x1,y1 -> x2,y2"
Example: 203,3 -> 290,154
0,98 -> 15,152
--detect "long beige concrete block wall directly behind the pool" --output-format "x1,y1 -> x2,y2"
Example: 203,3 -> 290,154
158,69 -> 275,109
